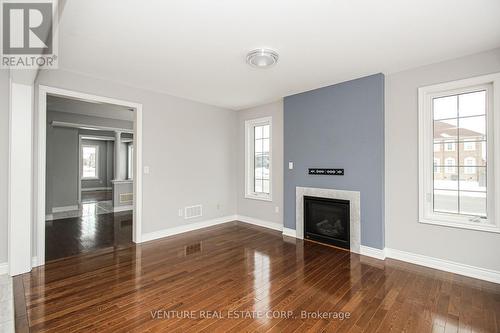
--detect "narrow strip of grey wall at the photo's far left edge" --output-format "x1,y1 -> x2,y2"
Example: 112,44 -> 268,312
0,69 -> 9,264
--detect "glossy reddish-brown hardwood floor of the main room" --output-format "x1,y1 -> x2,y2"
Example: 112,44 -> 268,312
17,222 -> 500,333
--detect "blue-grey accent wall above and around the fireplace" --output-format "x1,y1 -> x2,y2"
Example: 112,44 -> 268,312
284,74 -> 385,249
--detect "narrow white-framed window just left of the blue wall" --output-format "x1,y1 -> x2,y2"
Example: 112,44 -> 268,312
245,117 -> 272,201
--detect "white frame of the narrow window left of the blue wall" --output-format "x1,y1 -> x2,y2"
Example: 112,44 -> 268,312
245,117 -> 273,201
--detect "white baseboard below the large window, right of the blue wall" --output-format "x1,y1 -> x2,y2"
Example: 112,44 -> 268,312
385,248 -> 500,283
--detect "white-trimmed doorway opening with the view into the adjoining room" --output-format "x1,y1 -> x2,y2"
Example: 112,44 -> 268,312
36,86 -> 142,265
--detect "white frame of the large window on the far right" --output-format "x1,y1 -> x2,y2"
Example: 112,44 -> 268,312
418,73 -> 500,233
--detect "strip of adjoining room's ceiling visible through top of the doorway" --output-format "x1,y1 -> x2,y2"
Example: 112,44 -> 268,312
47,95 -> 134,121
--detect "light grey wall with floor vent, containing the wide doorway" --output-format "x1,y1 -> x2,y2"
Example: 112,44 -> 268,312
35,70 -> 236,248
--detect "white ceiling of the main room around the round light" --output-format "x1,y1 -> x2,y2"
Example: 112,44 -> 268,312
59,0 -> 500,109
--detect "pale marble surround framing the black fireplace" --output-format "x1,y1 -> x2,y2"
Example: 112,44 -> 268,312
295,186 -> 361,253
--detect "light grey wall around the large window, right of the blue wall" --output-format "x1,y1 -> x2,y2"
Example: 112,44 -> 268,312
385,49 -> 500,271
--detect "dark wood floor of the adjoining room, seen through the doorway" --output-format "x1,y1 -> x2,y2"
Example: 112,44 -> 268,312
45,211 -> 132,262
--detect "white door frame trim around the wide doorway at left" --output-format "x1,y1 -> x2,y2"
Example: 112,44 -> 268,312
34,85 -> 142,266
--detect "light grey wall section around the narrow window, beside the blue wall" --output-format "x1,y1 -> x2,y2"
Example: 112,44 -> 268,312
236,100 -> 283,224
